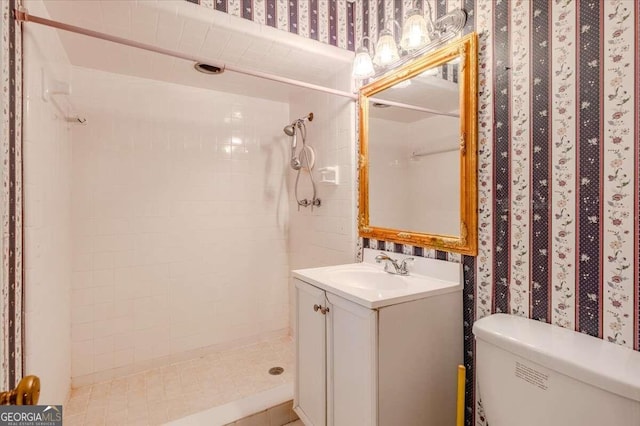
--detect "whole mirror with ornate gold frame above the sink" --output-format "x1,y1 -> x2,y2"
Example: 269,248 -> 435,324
358,33 -> 478,255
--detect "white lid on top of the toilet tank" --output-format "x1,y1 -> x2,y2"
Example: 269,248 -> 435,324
473,314 -> 640,401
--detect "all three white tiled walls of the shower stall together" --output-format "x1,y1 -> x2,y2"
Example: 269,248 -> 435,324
24,1 -> 356,420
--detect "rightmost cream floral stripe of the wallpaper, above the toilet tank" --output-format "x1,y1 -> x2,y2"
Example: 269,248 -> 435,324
600,1 -> 640,349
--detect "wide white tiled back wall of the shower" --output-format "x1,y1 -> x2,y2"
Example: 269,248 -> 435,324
72,68 -> 289,384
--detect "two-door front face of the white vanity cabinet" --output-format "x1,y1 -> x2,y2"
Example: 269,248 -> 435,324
294,279 -> 377,426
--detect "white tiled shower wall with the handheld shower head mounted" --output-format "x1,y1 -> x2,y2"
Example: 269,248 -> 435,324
286,67 -> 357,332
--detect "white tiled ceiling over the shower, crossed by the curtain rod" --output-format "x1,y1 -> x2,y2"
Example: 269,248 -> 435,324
33,0 -> 353,101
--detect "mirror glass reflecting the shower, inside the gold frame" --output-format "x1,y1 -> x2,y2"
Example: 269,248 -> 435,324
369,58 -> 460,236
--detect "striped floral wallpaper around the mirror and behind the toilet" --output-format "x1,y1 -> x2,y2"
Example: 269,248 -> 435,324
356,0 -> 640,425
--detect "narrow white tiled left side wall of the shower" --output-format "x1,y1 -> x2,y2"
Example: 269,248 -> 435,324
23,1 -> 71,404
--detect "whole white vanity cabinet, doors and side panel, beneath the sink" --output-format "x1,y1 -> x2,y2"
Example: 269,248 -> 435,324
294,251 -> 463,426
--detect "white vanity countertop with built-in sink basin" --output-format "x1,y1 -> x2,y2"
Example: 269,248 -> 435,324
292,249 -> 462,309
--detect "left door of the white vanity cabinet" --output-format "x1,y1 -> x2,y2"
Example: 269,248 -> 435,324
294,279 -> 327,426
